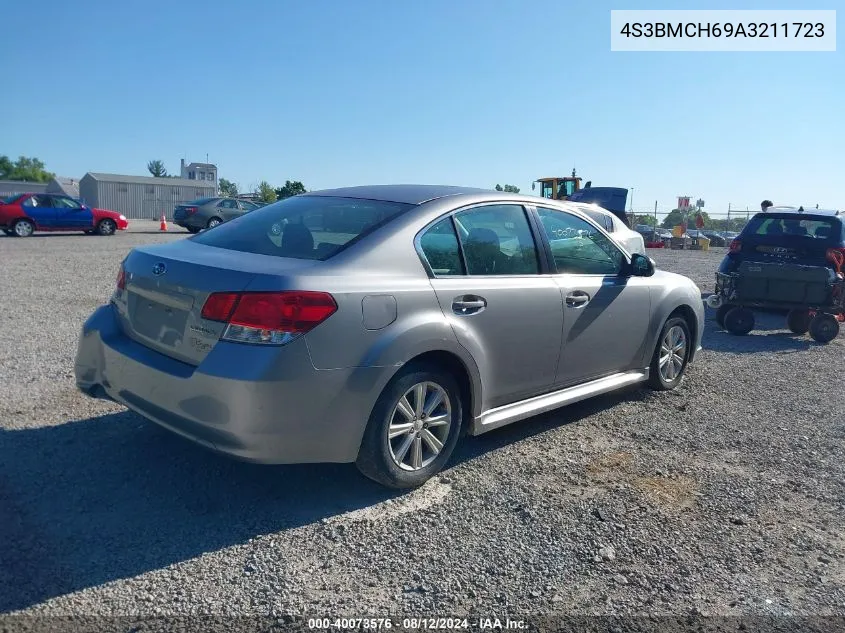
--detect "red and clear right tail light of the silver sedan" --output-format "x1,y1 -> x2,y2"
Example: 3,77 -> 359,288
202,290 -> 337,344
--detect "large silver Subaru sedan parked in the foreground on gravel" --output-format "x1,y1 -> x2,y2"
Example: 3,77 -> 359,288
75,185 -> 704,488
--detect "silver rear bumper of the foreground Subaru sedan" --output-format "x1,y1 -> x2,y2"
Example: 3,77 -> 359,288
75,305 -> 389,464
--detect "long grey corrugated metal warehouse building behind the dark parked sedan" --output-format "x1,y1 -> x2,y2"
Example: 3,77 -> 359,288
79,172 -> 217,220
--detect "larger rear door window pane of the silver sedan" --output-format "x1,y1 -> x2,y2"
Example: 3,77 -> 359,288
455,204 -> 540,275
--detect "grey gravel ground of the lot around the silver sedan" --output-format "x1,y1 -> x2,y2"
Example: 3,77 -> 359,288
0,222 -> 845,617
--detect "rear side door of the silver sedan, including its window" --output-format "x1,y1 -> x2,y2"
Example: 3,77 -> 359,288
420,204 -> 563,409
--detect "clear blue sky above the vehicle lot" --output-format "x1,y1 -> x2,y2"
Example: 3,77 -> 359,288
0,0 -> 845,212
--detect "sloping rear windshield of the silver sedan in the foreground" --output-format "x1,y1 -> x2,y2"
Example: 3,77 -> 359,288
189,196 -> 413,260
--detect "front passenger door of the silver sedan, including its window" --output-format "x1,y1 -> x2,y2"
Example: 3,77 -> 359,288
536,207 -> 651,387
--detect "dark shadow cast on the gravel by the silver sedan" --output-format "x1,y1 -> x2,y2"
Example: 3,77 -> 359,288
0,388 -> 645,613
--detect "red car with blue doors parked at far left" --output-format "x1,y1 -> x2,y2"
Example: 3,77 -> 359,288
0,193 -> 129,237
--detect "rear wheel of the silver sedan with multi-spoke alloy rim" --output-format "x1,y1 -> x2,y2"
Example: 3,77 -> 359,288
355,365 -> 463,489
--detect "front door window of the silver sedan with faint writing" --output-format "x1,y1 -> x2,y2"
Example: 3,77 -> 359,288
537,208 -> 625,275
